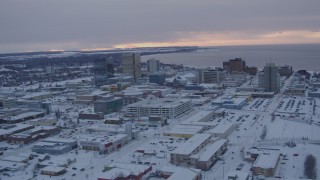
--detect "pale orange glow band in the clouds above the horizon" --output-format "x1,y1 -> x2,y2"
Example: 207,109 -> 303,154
113,31 -> 320,49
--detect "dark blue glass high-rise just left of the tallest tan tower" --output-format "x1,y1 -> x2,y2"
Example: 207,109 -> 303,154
93,57 -> 114,87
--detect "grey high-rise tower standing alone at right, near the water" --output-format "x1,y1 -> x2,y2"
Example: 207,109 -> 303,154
263,63 -> 280,92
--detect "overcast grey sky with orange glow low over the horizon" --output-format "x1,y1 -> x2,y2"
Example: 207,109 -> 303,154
0,0 -> 320,53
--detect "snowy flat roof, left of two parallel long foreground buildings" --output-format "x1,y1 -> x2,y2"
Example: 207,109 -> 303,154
171,134 -> 211,155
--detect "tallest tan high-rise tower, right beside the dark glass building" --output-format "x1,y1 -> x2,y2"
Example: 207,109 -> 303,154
122,53 -> 141,81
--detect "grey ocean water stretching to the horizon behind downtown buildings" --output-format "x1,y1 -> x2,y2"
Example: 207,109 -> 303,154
142,44 -> 320,72
